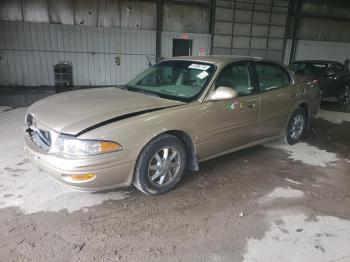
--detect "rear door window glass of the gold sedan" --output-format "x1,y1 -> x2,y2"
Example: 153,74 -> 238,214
256,63 -> 291,92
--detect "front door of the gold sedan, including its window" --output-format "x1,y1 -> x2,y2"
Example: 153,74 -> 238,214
197,63 -> 259,159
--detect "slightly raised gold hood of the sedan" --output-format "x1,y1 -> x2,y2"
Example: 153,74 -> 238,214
28,87 -> 183,135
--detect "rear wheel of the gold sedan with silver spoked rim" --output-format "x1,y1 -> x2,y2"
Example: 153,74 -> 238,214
282,107 -> 307,145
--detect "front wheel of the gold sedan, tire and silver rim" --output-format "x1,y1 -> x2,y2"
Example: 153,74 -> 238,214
133,135 -> 187,195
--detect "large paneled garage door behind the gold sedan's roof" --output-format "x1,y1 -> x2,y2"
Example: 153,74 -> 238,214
212,0 -> 289,61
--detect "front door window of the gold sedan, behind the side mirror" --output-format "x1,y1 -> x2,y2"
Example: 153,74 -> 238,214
216,64 -> 253,96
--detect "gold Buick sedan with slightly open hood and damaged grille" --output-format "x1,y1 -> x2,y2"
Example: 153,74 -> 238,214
25,56 -> 319,195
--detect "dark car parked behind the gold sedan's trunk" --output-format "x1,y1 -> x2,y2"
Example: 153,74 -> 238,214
289,60 -> 350,104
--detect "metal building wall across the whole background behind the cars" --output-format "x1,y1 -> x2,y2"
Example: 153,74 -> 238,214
0,0 -> 350,89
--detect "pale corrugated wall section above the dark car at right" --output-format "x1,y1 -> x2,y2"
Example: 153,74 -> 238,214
284,39 -> 350,64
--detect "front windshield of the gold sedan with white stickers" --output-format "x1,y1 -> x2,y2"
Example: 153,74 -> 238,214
127,61 -> 215,102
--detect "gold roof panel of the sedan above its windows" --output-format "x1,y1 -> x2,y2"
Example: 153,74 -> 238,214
166,55 -> 282,65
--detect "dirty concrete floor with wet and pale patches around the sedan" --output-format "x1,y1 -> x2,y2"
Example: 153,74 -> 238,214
0,107 -> 350,262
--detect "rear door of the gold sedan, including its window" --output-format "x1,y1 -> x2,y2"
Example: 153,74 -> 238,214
254,62 -> 297,139
